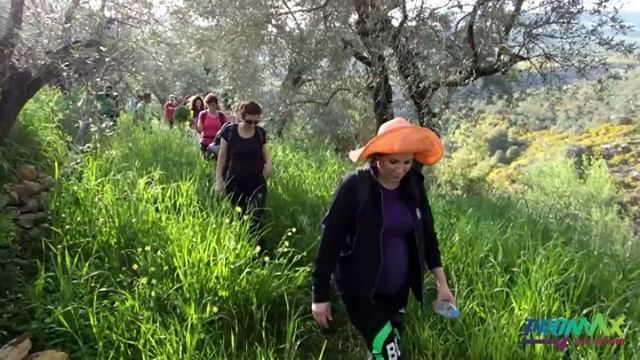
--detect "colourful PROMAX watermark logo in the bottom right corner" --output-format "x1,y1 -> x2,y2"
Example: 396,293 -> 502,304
520,313 -> 624,351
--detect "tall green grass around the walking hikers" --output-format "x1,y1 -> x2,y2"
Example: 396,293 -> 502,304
0,91 -> 640,359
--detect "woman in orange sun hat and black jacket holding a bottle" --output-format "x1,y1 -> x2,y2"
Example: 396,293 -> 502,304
311,118 -> 455,359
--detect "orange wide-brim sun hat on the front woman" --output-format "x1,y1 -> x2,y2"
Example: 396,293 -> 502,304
349,117 -> 444,165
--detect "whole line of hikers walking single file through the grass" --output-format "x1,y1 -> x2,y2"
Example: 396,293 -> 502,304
96,86 -> 455,359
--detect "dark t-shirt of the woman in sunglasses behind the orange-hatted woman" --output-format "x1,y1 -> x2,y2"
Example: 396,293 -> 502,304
221,124 -> 267,179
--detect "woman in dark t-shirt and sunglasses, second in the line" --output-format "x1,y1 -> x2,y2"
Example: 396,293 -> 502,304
216,101 -> 273,245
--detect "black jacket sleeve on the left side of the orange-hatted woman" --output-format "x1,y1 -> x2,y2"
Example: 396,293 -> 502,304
311,174 -> 357,303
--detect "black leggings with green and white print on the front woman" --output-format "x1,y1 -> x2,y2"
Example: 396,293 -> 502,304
342,287 -> 409,360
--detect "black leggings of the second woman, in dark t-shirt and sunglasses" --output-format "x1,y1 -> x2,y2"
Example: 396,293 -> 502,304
225,175 -> 267,243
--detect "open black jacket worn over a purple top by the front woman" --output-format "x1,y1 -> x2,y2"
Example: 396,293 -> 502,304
312,168 -> 442,302
